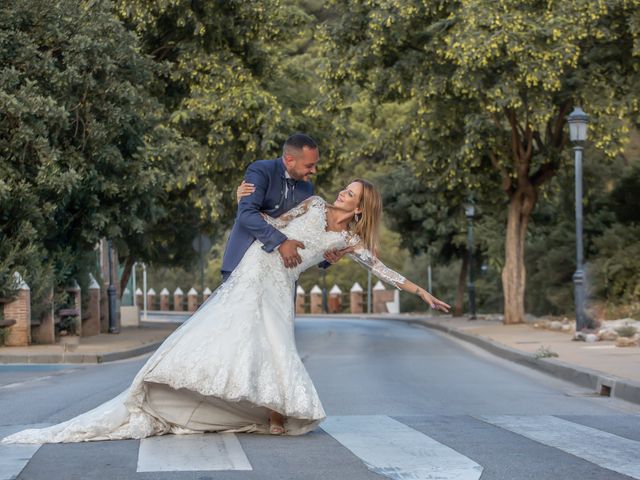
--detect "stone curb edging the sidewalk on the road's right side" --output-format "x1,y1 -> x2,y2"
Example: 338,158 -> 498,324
402,317 -> 640,404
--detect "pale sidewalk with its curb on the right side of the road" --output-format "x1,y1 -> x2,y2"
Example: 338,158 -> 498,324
396,315 -> 640,403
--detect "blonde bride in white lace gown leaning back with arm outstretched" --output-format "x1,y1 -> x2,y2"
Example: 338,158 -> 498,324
2,179 -> 450,443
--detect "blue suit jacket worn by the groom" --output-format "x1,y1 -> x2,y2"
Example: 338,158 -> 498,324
222,158 -> 313,273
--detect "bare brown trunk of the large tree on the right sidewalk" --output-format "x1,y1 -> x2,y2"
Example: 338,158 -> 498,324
502,184 -> 537,324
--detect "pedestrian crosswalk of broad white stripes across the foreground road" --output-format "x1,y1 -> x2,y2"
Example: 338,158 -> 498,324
0,415 -> 640,480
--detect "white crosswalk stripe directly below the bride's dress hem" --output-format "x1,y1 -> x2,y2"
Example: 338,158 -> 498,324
137,433 -> 253,472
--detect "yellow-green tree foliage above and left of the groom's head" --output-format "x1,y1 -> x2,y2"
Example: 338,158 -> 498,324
115,0 -> 322,223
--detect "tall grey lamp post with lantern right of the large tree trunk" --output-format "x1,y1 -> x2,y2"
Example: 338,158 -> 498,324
567,107 -> 589,332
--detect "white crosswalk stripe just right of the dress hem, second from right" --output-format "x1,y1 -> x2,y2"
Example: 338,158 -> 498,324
321,415 -> 482,480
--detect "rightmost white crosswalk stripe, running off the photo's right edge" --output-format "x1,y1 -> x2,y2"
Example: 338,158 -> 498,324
478,415 -> 640,479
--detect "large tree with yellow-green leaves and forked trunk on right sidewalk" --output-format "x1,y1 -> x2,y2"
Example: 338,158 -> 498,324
317,0 -> 640,323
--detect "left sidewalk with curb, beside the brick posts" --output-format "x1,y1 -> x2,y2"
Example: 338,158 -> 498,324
0,323 -> 179,364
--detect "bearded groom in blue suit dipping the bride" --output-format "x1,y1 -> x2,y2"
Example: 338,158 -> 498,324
222,133 -> 344,282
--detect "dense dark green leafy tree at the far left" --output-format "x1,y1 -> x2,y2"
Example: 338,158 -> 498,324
0,0 -> 174,306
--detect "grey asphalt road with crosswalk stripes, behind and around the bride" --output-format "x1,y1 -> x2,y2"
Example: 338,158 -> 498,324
0,318 -> 640,480
